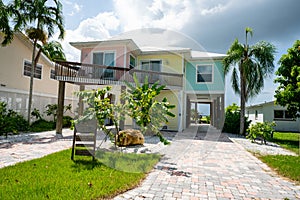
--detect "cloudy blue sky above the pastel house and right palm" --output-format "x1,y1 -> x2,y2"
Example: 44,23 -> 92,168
38,0 -> 300,108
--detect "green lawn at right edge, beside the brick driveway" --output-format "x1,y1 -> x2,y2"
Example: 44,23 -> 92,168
259,132 -> 300,184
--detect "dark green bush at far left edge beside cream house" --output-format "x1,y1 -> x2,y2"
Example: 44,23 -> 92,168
0,102 -> 29,135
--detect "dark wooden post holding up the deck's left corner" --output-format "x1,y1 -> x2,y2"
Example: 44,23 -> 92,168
56,81 -> 65,134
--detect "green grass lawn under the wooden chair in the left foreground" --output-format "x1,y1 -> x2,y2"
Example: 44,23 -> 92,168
0,150 -> 160,200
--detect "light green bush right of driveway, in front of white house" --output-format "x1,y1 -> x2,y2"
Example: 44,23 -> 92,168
247,122 -> 275,144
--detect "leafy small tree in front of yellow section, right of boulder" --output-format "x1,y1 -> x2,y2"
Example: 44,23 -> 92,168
124,74 -> 175,144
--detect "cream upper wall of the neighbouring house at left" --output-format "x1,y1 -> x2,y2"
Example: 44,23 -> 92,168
0,37 -> 78,98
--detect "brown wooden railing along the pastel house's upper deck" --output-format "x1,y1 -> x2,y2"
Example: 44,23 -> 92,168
55,61 -> 183,87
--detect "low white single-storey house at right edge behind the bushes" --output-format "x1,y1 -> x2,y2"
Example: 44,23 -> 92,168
246,101 -> 300,132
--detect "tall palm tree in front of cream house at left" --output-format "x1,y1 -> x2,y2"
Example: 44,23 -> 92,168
0,0 -> 65,122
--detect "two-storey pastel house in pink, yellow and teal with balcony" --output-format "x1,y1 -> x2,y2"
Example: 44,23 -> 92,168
64,39 -> 225,131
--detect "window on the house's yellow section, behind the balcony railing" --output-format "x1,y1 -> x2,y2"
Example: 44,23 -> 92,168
141,60 -> 162,83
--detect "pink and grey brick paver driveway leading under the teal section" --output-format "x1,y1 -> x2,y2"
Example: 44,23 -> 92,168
115,127 -> 300,200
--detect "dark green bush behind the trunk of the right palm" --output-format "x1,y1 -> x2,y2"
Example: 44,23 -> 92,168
222,110 -> 251,134
